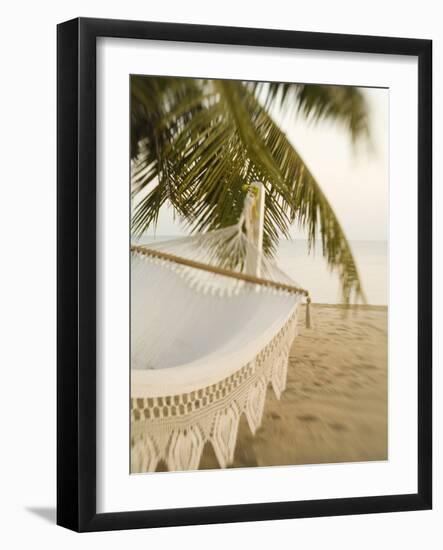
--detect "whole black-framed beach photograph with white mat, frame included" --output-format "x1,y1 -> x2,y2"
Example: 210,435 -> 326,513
57,19 -> 432,531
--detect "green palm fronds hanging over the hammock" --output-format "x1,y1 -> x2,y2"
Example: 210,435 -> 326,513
131,76 -> 369,303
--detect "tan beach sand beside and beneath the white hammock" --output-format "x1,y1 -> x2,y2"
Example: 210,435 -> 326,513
200,304 -> 388,469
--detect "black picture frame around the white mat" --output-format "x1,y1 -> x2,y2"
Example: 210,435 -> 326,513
57,18 -> 432,531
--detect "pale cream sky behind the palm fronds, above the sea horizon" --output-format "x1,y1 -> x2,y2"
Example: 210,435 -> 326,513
138,88 -> 389,241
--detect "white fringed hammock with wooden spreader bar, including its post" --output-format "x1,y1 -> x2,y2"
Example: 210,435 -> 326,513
131,185 -> 308,473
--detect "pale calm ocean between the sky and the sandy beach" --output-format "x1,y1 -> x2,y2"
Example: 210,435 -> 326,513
134,235 -> 388,305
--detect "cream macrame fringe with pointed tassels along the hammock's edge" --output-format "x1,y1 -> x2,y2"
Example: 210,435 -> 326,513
131,311 -> 298,473
